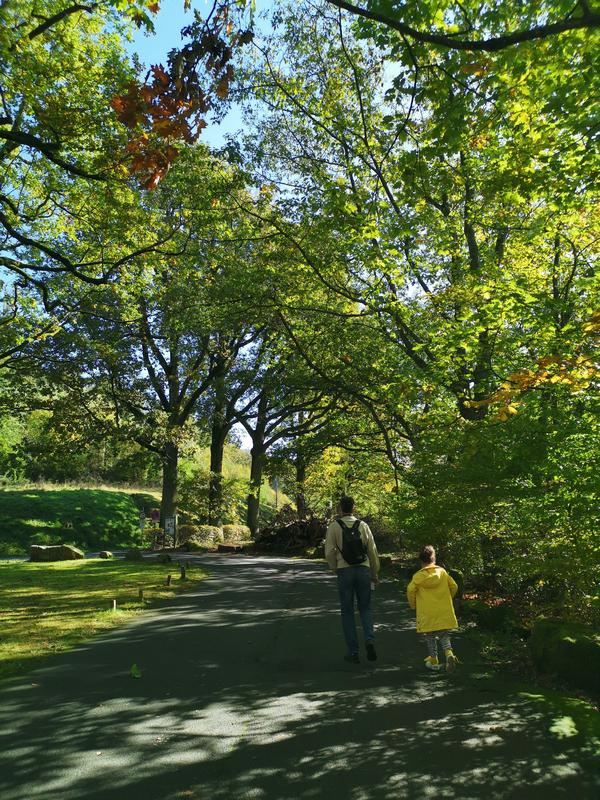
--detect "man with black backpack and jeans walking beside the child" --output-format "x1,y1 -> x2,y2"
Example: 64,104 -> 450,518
325,497 -> 379,664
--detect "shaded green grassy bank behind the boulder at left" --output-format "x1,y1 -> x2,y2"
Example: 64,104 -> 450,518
0,487 -> 158,555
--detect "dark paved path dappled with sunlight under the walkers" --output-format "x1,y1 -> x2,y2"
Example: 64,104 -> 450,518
0,556 -> 600,800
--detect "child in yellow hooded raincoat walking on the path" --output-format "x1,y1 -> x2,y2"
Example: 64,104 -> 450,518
406,544 -> 458,671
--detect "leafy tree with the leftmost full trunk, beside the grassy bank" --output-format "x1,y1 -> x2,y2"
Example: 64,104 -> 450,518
27,149 -> 270,536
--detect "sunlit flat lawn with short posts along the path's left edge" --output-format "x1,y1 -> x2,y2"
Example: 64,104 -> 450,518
0,559 -> 206,680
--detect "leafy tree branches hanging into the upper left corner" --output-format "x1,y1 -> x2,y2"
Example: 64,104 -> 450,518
0,0 -> 165,362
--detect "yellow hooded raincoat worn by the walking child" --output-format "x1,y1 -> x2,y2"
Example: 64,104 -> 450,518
406,564 -> 458,633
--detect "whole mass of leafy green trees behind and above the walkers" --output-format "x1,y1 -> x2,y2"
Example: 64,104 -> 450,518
0,0 -> 600,617
